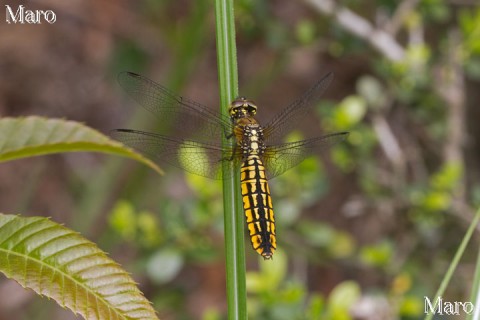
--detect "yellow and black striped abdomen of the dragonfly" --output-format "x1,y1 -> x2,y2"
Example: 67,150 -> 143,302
240,154 -> 277,259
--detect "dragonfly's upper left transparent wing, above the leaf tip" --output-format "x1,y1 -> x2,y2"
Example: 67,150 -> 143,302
118,72 -> 232,144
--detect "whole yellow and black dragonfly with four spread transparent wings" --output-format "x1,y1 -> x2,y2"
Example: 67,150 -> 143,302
113,72 -> 348,259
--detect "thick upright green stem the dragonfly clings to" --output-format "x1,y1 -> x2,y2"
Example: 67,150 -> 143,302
215,0 -> 247,319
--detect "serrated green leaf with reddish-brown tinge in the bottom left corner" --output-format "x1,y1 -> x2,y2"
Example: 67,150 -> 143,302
0,214 -> 158,320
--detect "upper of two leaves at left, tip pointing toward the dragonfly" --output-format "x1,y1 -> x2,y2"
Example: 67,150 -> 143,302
0,116 -> 163,174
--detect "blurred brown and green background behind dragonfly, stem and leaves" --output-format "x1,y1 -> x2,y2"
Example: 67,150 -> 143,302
0,0 -> 480,320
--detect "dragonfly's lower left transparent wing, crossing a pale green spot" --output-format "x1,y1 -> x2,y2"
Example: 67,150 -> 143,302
112,129 -> 239,179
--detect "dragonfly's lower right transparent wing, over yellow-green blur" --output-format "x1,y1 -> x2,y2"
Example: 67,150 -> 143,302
263,132 -> 348,179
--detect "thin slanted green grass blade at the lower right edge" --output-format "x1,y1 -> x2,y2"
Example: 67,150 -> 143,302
425,209 -> 480,320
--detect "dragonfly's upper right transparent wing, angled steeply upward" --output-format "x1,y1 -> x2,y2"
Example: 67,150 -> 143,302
263,72 -> 333,145
